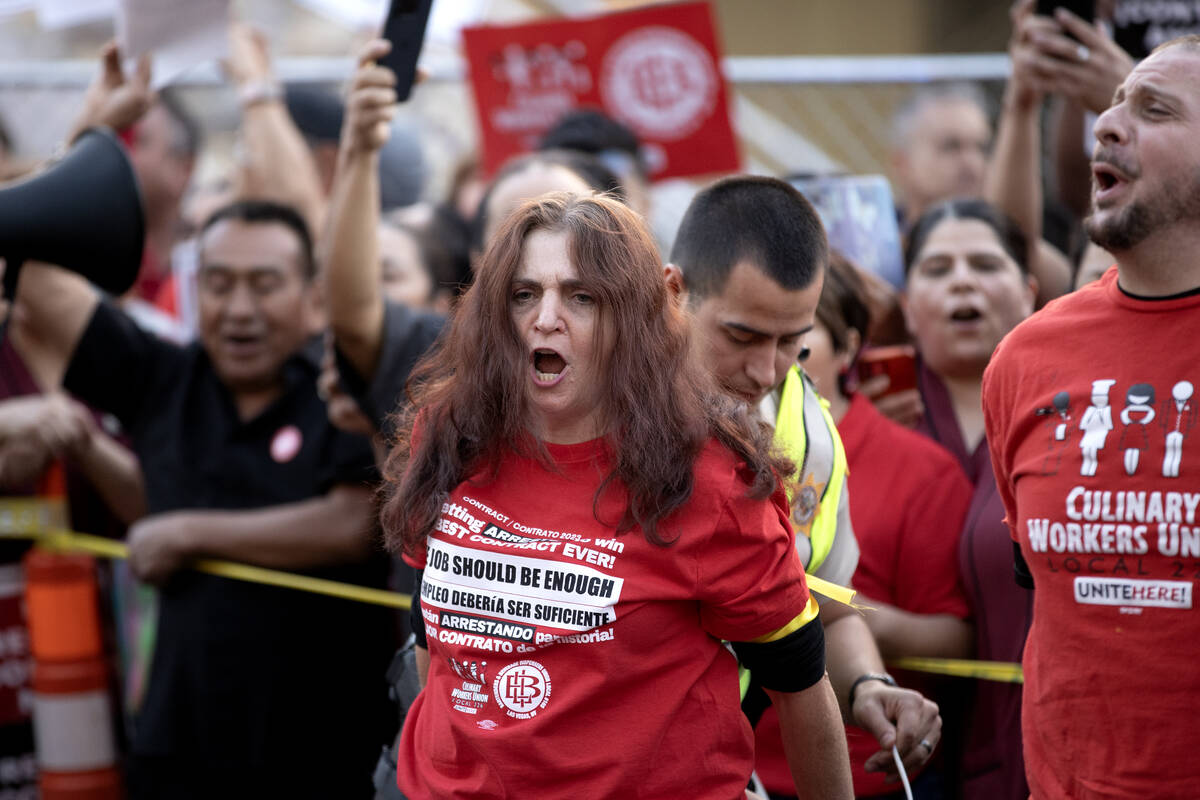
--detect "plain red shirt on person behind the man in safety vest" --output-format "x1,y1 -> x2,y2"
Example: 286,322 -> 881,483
755,395 -> 971,796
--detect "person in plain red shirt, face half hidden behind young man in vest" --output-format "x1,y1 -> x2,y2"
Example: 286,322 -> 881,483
755,253 -> 973,799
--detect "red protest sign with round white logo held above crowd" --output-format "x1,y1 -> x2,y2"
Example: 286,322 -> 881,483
463,2 -> 738,179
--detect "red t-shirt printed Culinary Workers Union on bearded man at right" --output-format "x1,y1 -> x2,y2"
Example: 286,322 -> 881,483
984,270 -> 1200,800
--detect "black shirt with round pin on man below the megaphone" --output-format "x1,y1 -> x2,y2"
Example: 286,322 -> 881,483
64,303 -> 396,782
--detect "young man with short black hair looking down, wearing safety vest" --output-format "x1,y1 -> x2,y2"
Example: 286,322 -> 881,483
665,176 -> 942,786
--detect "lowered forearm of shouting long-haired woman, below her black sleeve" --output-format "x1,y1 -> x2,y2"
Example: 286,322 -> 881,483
767,675 -> 854,800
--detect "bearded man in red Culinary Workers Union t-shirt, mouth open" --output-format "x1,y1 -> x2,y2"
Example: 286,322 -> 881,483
984,36 -> 1200,800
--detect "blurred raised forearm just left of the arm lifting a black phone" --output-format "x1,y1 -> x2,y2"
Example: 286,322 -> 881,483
236,100 -> 325,236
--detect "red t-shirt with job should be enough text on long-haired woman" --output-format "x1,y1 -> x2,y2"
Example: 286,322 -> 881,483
397,441 -> 808,800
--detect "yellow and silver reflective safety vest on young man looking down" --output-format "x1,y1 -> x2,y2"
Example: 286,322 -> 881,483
775,366 -> 847,572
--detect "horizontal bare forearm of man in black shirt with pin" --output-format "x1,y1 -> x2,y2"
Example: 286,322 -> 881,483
175,486 -> 374,570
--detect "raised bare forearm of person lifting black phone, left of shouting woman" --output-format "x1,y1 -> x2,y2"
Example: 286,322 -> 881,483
322,146 -> 384,380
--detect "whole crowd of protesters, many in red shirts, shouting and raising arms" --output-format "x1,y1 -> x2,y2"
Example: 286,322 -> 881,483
0,0 -> 1200,800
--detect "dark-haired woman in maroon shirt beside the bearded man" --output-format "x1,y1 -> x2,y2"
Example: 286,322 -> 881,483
904,200 -> 1037,800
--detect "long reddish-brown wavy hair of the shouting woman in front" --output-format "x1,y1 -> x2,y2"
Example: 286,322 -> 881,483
382,193 -> 792,553
